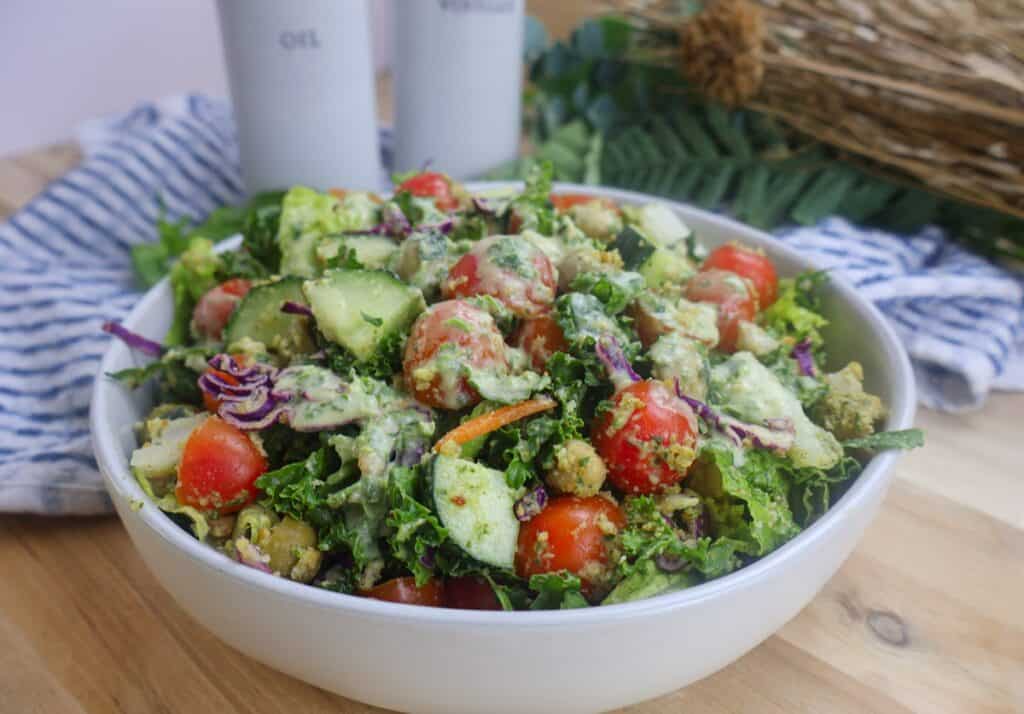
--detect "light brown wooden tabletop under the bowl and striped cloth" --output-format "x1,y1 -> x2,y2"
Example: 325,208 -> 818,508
0,69 -> 1024,714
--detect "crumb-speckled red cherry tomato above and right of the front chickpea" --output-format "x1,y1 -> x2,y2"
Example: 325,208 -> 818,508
591,380 -> 697,494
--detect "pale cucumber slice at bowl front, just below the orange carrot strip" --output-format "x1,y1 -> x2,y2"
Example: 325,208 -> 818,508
432,456 -> 519,570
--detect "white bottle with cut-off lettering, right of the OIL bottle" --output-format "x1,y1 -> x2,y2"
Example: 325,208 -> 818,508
393,0 -> 524,179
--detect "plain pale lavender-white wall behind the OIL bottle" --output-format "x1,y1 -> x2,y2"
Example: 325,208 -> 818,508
0,0 -> 390,156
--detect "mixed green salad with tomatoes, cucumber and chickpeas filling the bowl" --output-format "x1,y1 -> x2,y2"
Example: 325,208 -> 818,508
106,165 -> 921,610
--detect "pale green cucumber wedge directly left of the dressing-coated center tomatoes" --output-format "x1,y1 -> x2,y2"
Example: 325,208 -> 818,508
302,269 -> 426,362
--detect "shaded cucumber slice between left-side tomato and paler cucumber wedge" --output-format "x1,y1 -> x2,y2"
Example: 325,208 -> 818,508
224,277 -> 315,358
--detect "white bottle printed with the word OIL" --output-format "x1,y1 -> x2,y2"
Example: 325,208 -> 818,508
217,0 -> 382,193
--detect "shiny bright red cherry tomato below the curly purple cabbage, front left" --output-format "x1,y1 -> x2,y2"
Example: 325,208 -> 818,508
174,417 -> 267,514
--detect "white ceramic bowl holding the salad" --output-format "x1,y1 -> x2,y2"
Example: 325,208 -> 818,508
91,184 -> 915,714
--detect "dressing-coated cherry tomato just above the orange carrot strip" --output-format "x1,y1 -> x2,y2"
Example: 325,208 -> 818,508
402,300 -> 508,409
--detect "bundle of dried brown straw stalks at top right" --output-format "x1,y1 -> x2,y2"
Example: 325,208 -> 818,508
609,0 -> 1024,216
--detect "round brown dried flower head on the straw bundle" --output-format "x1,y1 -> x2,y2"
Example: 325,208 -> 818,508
679,0 -> 764,107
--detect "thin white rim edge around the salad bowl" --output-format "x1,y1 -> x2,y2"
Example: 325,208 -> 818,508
89,181 -> 916,628
